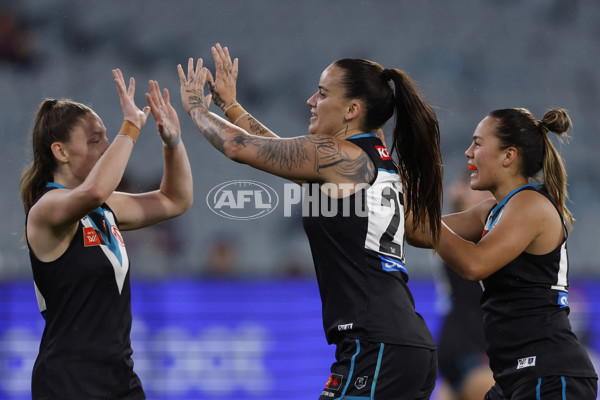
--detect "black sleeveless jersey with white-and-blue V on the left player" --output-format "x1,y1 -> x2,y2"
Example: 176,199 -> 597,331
29,187 -> 146,400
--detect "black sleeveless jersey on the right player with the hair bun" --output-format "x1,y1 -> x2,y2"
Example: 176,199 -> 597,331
481,185 -> 596,395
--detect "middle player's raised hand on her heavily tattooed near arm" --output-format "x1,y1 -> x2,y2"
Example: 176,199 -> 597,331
177,58 -> 212,114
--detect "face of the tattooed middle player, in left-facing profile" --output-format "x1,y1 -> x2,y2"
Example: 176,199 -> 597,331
306,65 -> 350,136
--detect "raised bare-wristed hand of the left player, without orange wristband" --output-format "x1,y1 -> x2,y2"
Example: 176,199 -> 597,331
146,80 -> 181,147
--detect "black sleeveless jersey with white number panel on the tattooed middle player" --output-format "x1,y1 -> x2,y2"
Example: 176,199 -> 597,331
303,133 -> 435,349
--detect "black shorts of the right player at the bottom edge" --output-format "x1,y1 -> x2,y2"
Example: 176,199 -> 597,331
484,376 -> 598,400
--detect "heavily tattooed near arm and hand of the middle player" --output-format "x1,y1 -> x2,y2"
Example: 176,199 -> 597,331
177,58 -> 373,183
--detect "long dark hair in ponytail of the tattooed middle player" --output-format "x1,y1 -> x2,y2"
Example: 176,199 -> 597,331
333,59 -> 443,242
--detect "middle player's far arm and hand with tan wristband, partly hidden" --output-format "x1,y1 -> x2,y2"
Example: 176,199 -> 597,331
207,43 -> 278,137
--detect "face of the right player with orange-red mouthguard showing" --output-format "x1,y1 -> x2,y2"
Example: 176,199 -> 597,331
465,117 -> 506,191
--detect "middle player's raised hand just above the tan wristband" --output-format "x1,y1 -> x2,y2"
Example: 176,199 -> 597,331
207,43 -> 238,110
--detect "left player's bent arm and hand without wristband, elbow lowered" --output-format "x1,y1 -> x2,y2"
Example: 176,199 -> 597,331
108,81 -> 193,230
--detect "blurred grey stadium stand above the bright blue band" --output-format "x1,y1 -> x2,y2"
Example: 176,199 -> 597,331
0,0 -> 600,279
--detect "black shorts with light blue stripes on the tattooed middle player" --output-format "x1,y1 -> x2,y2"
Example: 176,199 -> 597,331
319,338 -> 437,400
